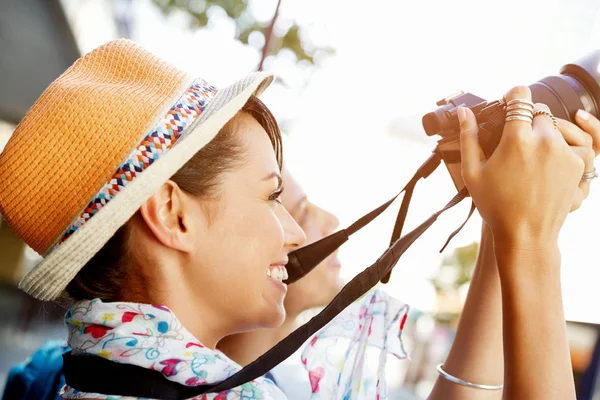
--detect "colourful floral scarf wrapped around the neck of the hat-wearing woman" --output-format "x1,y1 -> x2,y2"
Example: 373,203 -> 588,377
62,299 -> 286,400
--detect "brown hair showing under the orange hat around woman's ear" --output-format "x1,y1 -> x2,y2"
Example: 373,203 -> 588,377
66,96 -> 282,301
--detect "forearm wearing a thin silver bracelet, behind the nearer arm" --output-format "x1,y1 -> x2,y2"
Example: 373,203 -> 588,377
429,224 -> 504,400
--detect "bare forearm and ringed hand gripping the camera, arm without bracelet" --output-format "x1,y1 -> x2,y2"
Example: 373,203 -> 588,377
459,87 -> 580,400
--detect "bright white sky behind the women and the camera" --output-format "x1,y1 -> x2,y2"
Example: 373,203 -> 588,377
63,0 -> 600,323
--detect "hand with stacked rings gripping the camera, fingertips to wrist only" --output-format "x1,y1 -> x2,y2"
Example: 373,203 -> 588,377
458,86 -> 584,251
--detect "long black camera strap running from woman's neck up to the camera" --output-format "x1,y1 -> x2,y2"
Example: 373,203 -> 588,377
63,153 -> 473,399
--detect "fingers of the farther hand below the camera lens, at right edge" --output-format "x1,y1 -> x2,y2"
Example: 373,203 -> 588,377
558,110 -> 600,211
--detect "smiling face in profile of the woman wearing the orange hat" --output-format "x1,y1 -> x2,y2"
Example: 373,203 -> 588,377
186,114 -> 306,333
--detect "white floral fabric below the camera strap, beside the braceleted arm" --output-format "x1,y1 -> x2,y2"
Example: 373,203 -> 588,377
301,289 -> 409,400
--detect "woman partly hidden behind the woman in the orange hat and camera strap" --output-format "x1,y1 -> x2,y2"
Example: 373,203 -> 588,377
217,168 -> 418,400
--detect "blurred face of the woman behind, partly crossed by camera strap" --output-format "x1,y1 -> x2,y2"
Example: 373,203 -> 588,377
281,168 -> 343,314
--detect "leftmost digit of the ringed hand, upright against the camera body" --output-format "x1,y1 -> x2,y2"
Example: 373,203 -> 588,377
457,107 -> 485,185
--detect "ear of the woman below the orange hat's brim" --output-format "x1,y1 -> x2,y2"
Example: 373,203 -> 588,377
140,181 -> 194,252
